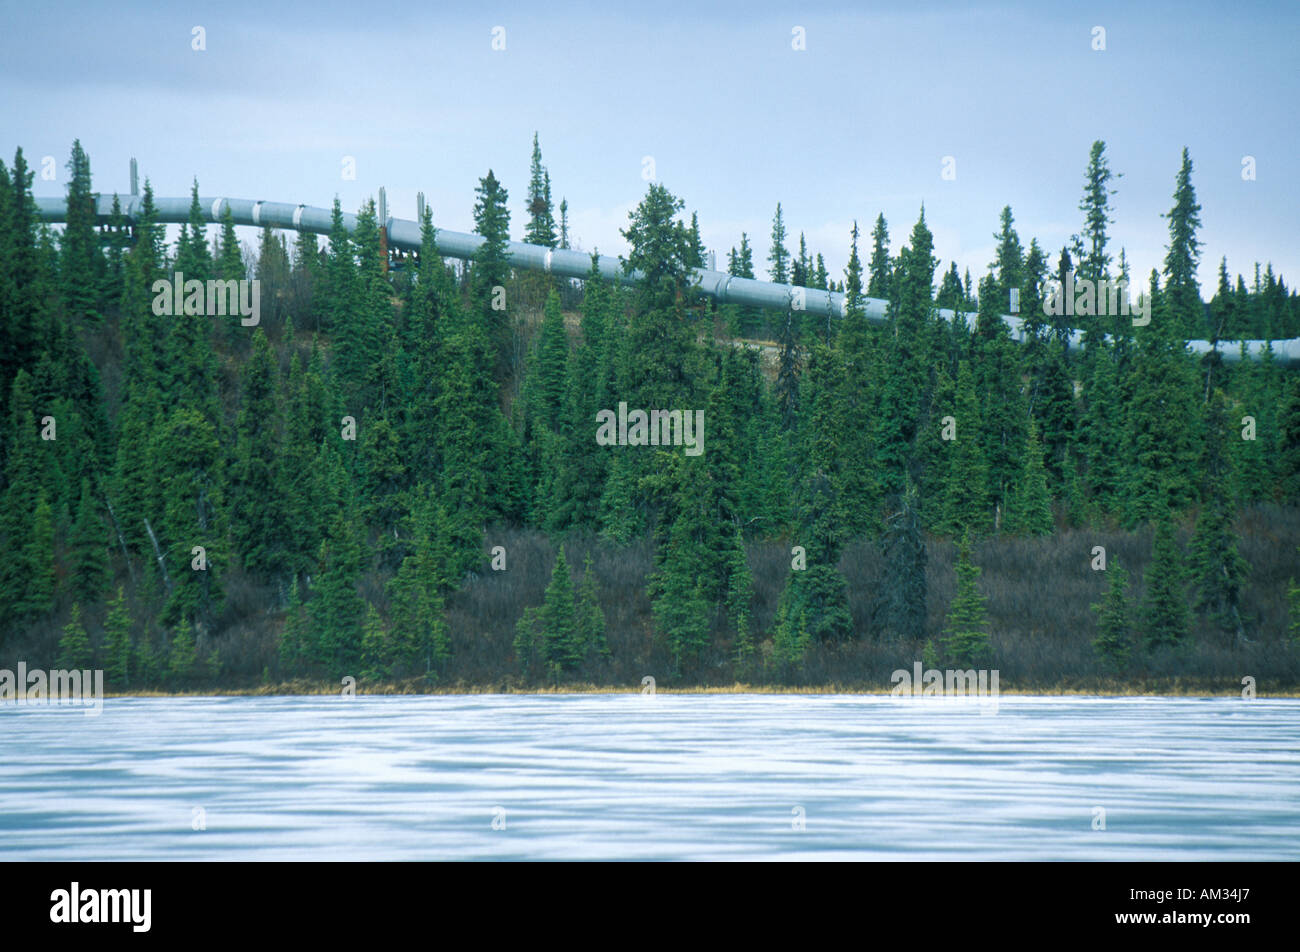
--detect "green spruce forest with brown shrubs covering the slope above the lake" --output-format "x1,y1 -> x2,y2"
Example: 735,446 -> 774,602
0,135 -> 1300,696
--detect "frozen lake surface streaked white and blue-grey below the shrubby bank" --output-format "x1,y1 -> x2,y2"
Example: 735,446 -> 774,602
0,693 -> 1300,861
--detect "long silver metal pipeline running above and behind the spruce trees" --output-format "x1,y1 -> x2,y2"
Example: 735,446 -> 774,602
36,194 -> 1300,367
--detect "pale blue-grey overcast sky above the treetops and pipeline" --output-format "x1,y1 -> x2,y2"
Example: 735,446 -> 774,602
0,0 -> 1300,295
